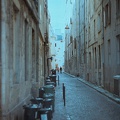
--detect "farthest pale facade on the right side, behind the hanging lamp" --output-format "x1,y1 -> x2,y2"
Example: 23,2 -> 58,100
65,1 -> 78,75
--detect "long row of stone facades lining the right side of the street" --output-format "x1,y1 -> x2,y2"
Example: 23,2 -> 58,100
65,0 -> 120,96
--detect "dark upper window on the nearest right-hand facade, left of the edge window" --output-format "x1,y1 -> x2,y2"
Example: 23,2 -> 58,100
104,1 -> 111,27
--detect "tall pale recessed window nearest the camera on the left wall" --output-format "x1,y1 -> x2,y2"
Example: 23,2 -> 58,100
11,4 -> 20,84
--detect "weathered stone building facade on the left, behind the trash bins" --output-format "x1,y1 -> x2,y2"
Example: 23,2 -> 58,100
0,0 -> 49,120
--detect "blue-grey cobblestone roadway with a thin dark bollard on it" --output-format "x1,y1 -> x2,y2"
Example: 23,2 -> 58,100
53,73 -> 120,120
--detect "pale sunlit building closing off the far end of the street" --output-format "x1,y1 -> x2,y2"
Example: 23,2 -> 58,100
50,29 -> 65,69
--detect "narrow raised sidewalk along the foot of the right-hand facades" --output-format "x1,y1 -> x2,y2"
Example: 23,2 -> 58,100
65,72 -> 120,104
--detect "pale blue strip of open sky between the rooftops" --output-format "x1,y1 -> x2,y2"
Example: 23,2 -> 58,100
48,0 -> 73,33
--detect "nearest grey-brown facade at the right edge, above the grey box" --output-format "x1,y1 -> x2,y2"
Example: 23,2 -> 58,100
103,0 -> 120,92
